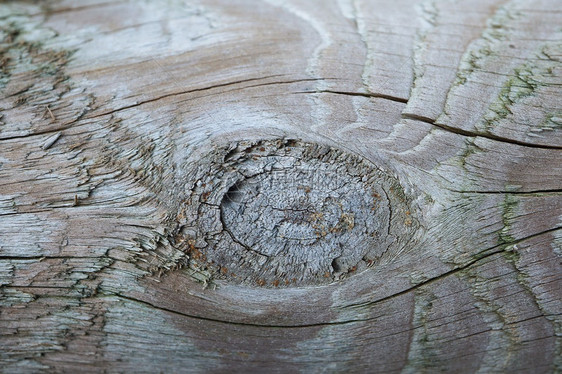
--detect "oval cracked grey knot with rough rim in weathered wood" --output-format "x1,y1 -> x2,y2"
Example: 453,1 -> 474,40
177,139 -> 418,288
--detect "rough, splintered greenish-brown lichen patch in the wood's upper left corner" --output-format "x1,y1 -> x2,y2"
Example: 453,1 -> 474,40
0,6 -> 94,137
